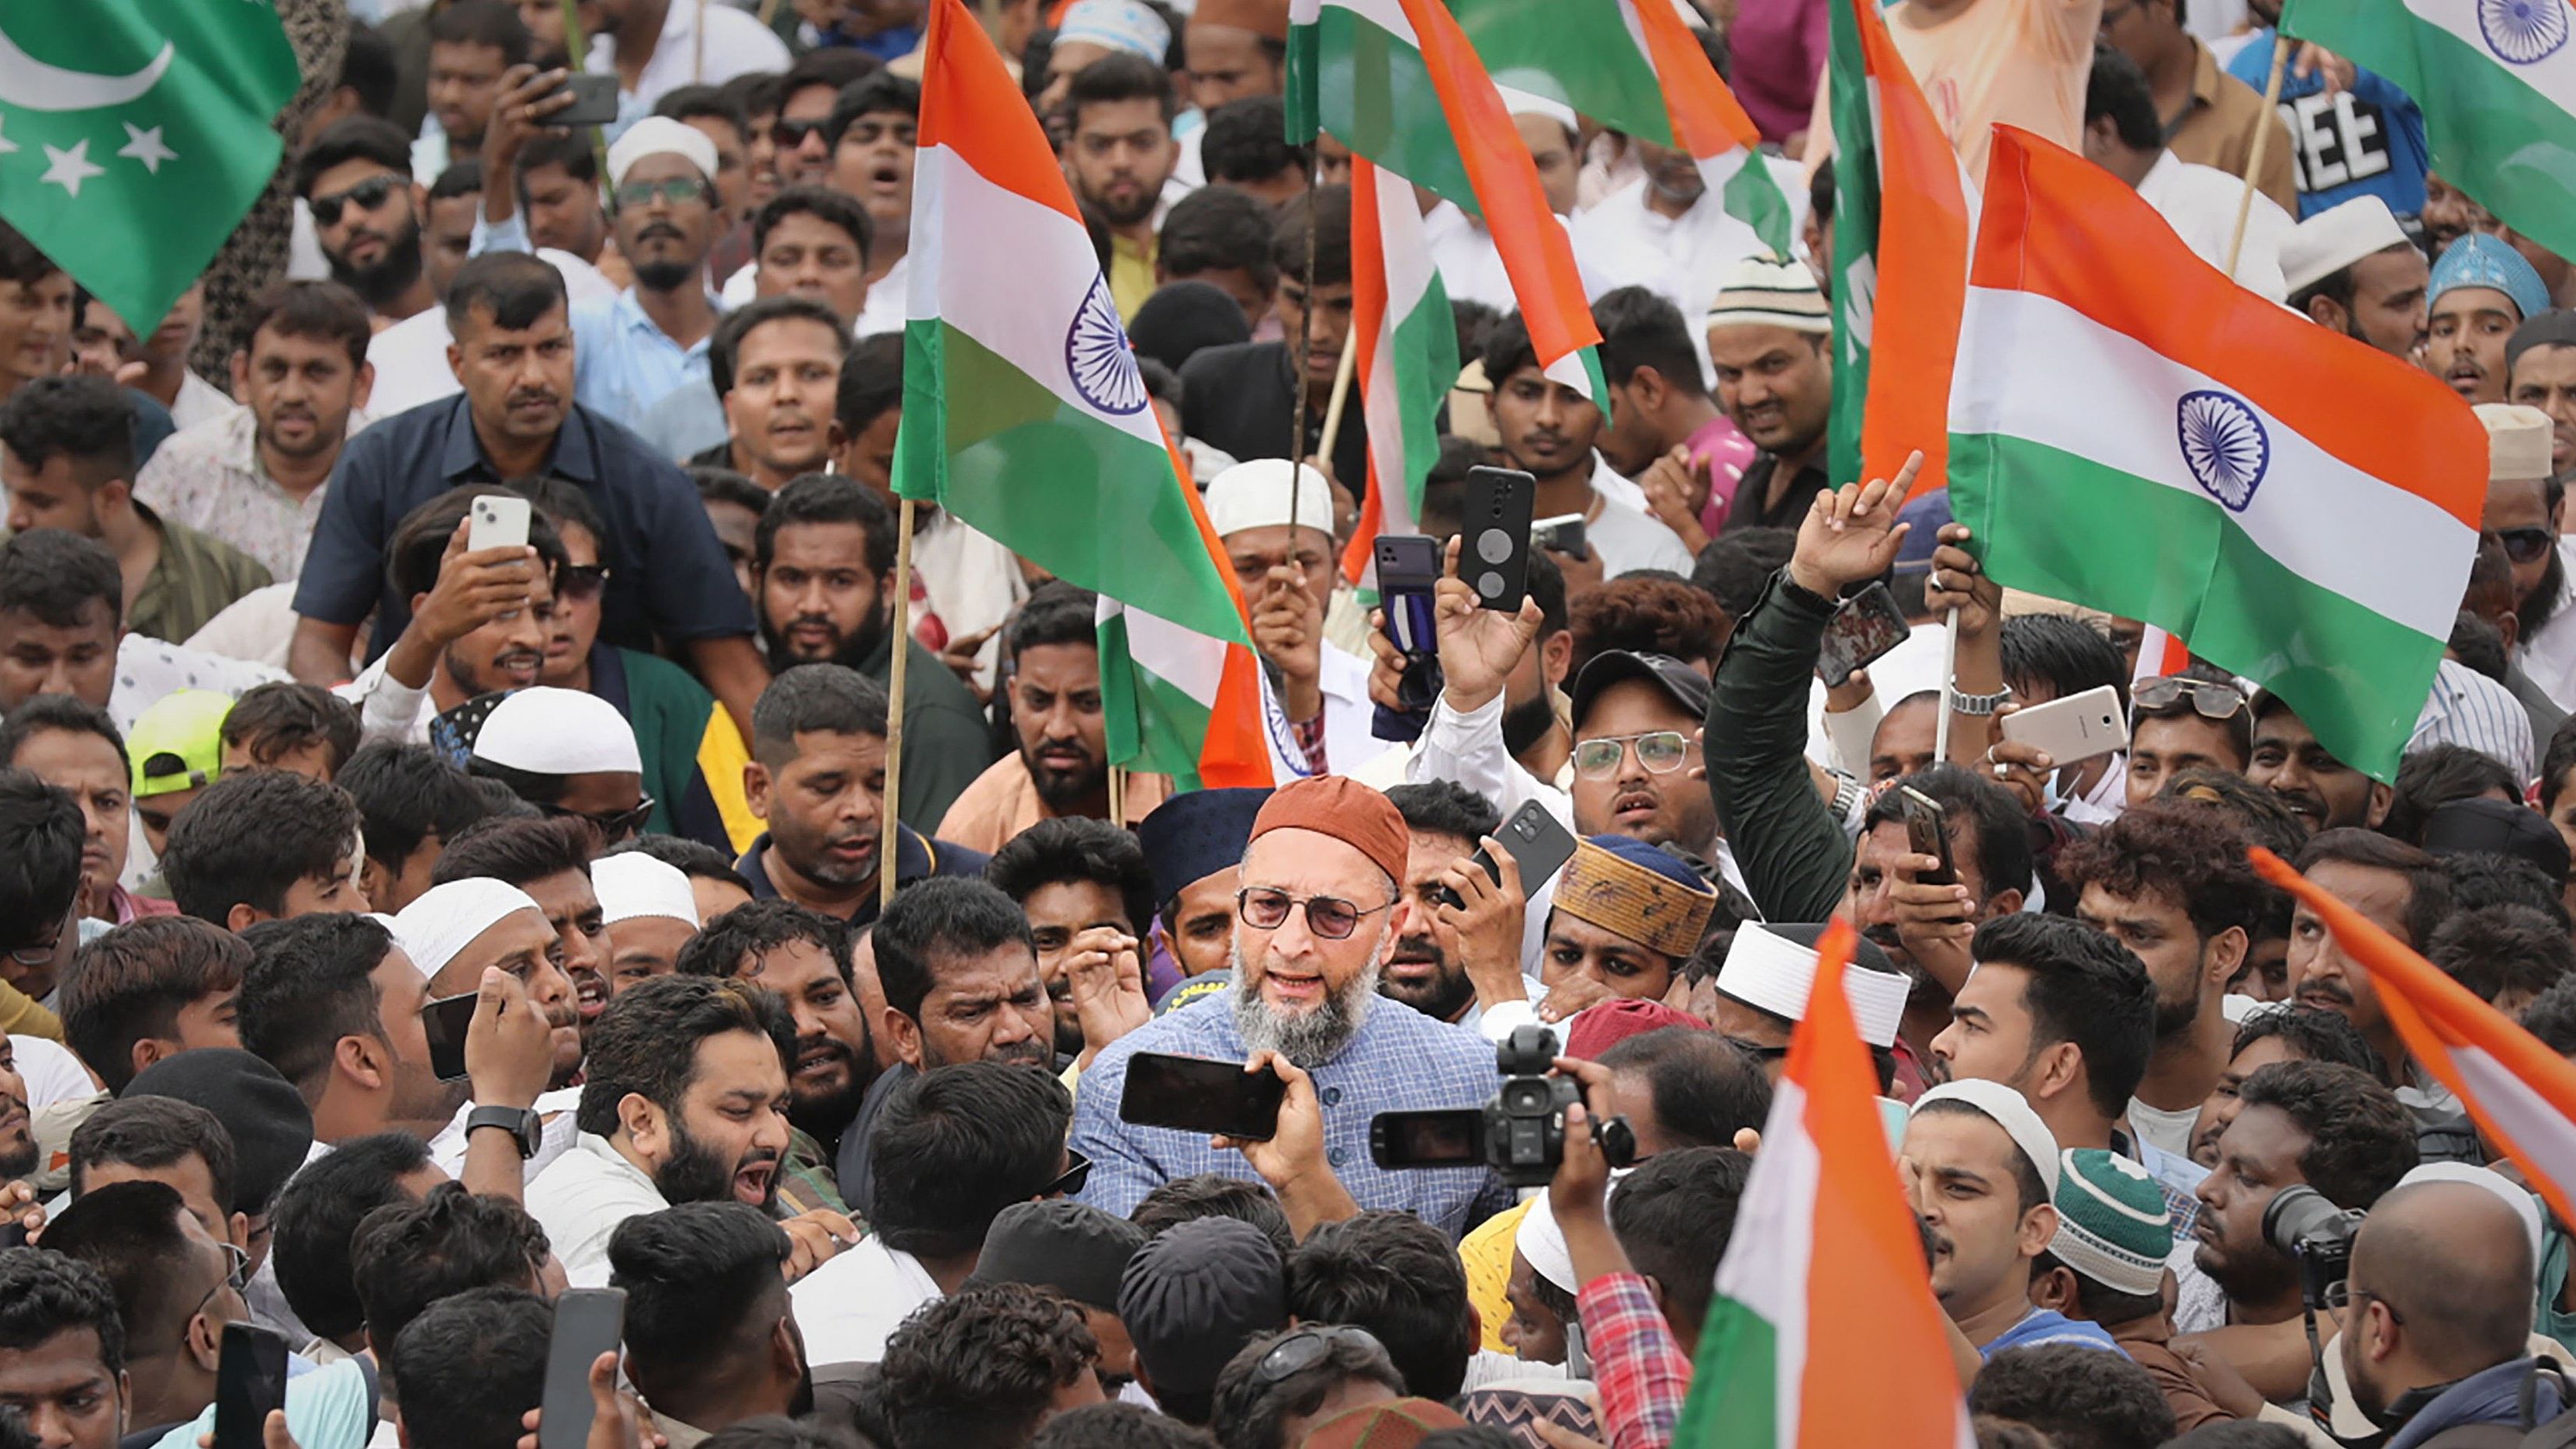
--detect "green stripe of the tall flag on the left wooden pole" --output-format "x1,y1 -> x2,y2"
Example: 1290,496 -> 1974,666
894,317 -> 1245,640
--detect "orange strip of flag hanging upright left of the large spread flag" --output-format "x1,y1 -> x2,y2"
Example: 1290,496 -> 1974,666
1850,0 -> 1971,497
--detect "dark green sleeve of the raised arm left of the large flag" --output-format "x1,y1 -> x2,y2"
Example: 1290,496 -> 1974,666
1703,570 -> 1852,920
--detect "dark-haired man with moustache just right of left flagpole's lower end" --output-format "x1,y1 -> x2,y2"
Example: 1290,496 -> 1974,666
840,879 -> 1061,1215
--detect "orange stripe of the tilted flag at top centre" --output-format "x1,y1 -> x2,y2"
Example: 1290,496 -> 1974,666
1401,0 -> 1602,366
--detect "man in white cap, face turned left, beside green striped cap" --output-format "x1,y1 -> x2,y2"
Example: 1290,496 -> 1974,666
1896,1080 -> 2117,1359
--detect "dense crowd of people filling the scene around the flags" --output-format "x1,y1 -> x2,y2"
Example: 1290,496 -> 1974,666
0,0 -> 2576,1449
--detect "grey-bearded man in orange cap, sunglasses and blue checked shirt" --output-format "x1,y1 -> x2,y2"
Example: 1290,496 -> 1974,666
1072,776 -> 1512,1235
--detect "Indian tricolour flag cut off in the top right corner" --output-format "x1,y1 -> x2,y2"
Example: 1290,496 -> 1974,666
2283,0 -> 2576,255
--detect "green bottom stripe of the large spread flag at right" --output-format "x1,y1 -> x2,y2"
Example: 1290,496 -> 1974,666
1950,433 -> 2445,778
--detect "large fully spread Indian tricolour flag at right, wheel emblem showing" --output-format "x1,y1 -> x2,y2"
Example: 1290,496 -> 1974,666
1950,127 -> 2486,778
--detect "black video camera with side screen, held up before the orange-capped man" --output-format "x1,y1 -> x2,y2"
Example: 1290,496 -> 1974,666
1368,1026 -> 1636,1188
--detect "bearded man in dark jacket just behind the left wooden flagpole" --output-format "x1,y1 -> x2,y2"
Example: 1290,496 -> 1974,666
752,472 -> 992,830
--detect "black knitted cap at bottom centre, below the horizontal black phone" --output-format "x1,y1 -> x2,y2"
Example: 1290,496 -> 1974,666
1118,1217 -> 1288,1395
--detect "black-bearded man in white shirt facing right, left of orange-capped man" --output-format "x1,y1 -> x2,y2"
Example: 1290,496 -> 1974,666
528,975 -> 858,1284
